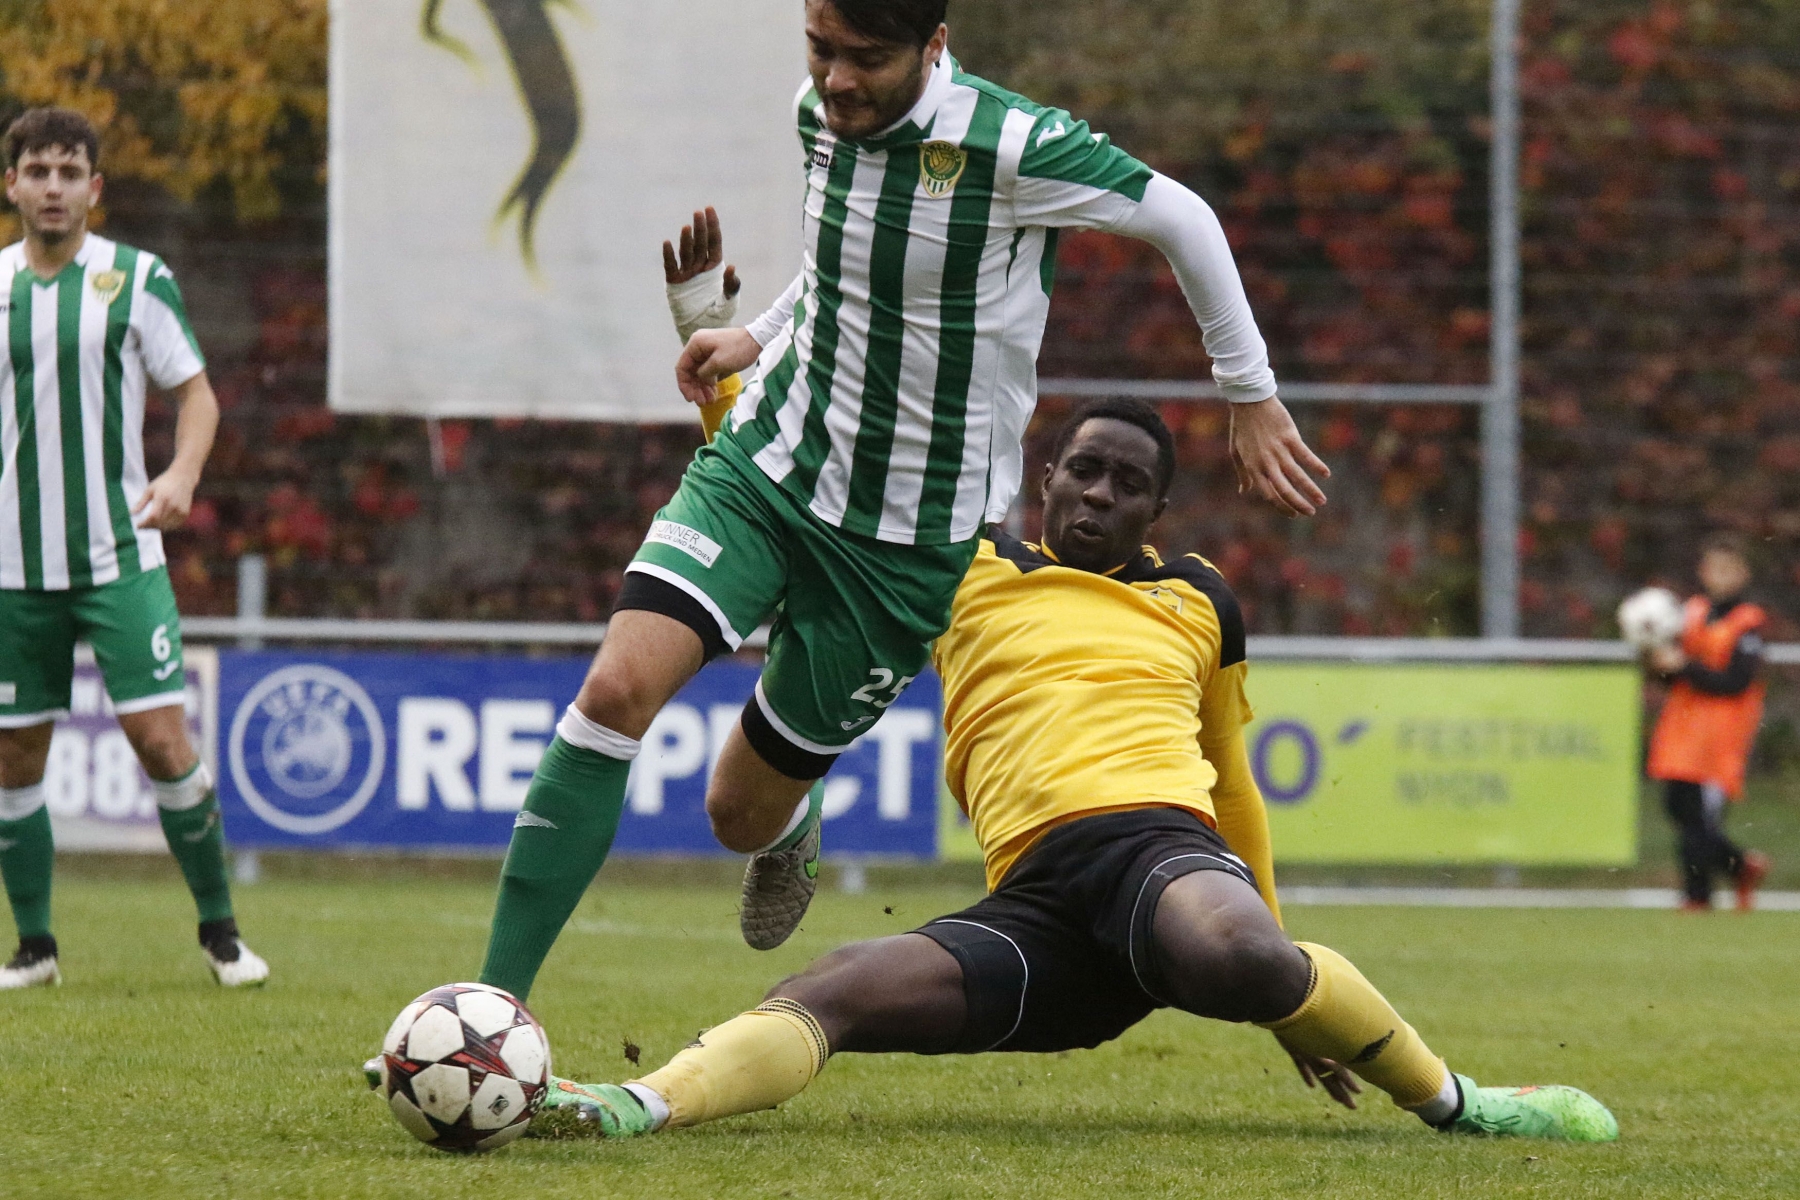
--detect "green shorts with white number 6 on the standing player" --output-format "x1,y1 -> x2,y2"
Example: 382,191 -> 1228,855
0,567 -> 187,729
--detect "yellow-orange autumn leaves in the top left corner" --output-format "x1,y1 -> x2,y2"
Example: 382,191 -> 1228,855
0,0 -> 328,221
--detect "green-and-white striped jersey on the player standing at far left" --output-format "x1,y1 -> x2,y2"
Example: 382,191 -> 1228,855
0,234 -> 205,590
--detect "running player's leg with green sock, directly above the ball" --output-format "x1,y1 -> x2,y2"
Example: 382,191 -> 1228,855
481,608 -> 706,1000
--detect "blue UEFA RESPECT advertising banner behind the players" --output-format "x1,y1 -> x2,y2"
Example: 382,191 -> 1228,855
218,651 -> 941,858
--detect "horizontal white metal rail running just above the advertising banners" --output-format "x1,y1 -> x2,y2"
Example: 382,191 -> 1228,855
182,617 -> 1800,666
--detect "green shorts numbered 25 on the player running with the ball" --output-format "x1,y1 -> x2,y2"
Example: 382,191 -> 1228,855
619,437 -> 979,779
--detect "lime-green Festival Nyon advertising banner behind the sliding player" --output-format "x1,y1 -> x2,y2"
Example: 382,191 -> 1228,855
940,662 -> 1642,865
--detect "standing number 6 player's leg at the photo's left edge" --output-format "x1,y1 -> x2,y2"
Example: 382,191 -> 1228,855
0,721 -> 63,990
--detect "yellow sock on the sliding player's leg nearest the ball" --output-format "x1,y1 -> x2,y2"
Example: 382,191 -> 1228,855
626,1000 -> 832,1128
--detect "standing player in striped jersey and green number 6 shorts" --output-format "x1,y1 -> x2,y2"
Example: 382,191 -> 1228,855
0,108 -> 268,990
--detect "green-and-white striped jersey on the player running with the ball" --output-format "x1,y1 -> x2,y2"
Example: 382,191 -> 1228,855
731,54 -> 1274,545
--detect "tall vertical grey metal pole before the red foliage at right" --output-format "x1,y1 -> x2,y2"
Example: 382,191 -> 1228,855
1481,0 -> 1519,637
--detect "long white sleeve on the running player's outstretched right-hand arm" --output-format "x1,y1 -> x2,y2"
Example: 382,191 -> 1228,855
1111,173 -> 1274,405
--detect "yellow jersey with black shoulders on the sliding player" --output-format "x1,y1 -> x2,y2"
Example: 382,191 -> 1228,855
932,531 -> 1274,907
